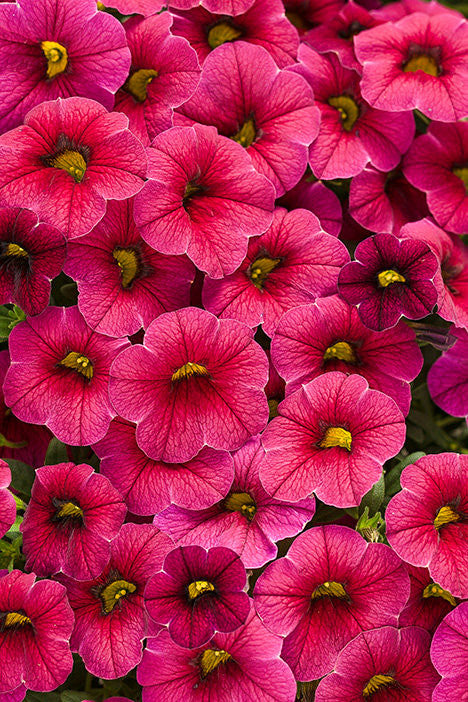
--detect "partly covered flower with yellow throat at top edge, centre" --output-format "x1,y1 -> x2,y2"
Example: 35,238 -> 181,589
172,0 -> 299,68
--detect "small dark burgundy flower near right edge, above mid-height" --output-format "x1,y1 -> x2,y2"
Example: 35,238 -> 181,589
338,234 -> 438,331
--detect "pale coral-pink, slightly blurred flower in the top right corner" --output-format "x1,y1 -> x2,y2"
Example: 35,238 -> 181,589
355,12 -> 468,122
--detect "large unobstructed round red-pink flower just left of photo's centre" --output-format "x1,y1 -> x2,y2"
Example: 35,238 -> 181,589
109,307 -> 268,462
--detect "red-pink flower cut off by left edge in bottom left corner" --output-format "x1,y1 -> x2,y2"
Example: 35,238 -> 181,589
0,570 -> 73,700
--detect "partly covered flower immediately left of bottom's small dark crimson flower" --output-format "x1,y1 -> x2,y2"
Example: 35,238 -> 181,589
57,524 -> 172,679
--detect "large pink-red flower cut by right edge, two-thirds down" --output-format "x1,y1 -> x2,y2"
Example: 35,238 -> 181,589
385,453 -> 468,598
